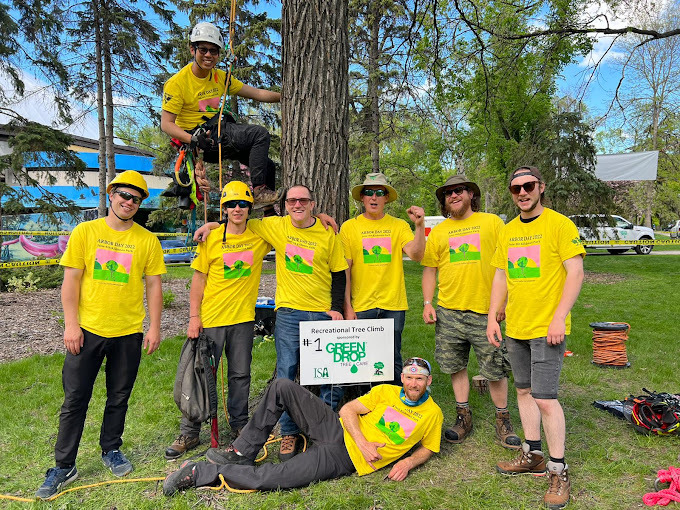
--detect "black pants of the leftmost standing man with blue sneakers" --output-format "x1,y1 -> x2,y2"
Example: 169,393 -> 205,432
54,330 -> 143,468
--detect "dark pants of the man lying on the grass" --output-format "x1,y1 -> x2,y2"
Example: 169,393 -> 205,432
196,379 -> 355,490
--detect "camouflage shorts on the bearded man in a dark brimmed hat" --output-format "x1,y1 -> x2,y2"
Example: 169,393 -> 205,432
434,306 -> 510,381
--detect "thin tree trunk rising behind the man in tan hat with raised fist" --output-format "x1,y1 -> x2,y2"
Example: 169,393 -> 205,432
368,0 -> 382,172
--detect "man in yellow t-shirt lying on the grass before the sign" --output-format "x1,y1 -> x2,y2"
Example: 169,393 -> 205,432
163,358 -> 443,496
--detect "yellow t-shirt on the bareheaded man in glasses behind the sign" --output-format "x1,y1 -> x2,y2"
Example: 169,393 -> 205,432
248,216 -> 347,312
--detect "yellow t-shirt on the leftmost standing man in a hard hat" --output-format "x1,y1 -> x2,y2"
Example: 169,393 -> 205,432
59,218 -> 165,338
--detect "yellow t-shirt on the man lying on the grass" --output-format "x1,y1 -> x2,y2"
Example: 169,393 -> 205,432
340,384 -> 444,476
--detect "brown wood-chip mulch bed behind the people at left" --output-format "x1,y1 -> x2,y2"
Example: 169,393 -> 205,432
0,274 -> 276,363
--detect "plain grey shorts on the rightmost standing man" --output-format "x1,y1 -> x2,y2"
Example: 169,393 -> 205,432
505,336 -> 567,399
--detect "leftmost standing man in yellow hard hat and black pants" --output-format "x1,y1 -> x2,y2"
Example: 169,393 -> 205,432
36,170 -> 165,499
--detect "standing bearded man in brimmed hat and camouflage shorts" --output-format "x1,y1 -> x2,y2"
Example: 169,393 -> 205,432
422,175 -> 521,450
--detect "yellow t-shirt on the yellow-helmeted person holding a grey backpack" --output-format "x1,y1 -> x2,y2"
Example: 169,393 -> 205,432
191,225 -> 271,328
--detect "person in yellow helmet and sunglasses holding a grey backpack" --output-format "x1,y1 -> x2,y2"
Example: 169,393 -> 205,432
165,181 -> 271,459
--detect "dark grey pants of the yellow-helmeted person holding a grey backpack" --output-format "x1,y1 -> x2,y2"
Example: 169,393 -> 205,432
180,321 -> 255,437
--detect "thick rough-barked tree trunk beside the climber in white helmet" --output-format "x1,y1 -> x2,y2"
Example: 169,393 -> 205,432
281,0 -> 349,223
